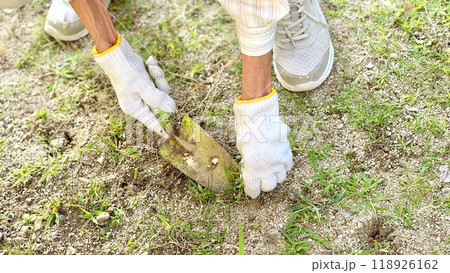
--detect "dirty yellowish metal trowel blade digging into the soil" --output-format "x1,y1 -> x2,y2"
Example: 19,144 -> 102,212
159,113 -> 239,190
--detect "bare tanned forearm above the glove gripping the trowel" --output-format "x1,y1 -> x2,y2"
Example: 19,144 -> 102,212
70,0 -> 117,53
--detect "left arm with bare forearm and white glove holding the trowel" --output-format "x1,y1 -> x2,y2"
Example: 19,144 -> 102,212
70,0 -> 176,138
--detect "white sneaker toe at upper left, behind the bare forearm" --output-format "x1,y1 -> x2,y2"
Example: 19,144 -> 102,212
44,0 -> 111,41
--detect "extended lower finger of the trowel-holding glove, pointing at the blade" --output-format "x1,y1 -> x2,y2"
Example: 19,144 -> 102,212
119,99 -> 169,139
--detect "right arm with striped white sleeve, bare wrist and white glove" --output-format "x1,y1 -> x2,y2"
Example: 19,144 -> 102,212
219,0 -> 293,198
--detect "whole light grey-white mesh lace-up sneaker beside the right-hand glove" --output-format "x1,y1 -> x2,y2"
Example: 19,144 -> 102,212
273,0 -> 334,91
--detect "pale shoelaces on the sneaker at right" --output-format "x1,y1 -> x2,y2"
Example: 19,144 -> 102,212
278,0 -> 319,46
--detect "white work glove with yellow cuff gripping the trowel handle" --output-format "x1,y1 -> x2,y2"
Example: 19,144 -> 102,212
93,34 -> 176,138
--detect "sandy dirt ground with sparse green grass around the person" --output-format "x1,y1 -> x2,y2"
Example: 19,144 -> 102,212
0,0 -> 450,254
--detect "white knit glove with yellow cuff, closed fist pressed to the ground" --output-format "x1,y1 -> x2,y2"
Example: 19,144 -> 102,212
233,89 -> 292,198
